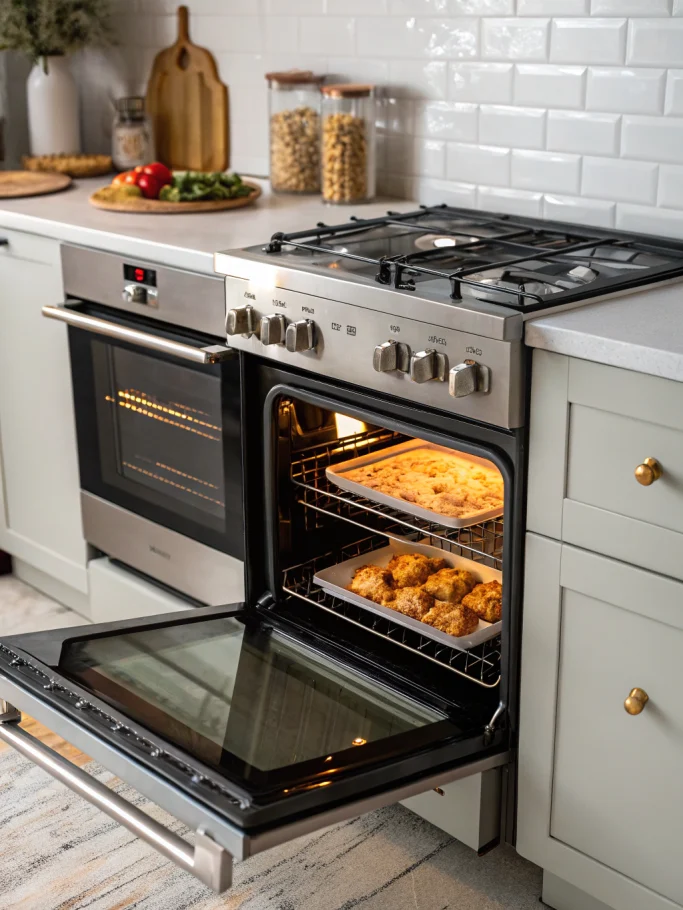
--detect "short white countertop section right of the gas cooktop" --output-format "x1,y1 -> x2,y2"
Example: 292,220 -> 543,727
525,282 -> 683,382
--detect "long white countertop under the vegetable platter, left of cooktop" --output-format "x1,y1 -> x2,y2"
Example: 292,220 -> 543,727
0,177 -> 417,274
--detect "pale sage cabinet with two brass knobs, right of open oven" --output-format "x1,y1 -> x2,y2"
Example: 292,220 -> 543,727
517,351 -> 683,910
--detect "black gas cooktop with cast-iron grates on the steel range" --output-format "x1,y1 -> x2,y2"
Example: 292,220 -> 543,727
263,205 -> 683,313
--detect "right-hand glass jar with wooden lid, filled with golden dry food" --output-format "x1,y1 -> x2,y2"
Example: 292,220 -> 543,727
322,84 -> 375,203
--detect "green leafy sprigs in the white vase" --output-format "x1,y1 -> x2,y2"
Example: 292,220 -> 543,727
0,0 -> 112,71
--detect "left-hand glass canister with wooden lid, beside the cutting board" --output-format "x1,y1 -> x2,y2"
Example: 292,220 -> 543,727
266,70 -> 324,193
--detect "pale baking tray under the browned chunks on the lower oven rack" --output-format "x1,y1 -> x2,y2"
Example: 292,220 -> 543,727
313,540 -> 503,651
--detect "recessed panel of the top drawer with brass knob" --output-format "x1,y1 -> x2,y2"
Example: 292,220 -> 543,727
567,404 -> 683,533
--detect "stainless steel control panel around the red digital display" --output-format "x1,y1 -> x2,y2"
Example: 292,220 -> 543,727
61,244 -> 225,338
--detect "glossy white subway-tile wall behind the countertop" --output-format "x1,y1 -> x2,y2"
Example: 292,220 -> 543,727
80,0 -> 683,236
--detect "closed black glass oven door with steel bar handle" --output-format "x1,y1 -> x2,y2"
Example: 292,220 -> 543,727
59,304 -> 244,564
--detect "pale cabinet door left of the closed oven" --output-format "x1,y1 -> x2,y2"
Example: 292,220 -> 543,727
0,231 -> 87,592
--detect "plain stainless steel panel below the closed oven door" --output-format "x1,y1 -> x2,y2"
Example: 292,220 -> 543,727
81,491 -> 244,606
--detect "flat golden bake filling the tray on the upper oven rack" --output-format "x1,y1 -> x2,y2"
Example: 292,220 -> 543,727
345,446 -> 504,518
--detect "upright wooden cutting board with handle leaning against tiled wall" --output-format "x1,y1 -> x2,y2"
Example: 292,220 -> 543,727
147,6 -> 230,171
